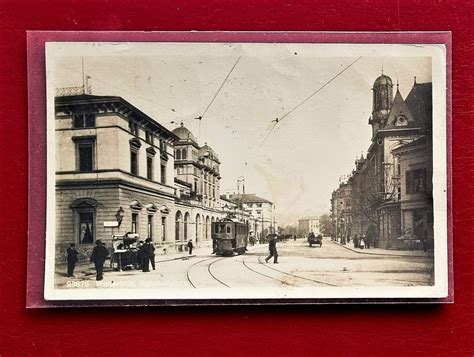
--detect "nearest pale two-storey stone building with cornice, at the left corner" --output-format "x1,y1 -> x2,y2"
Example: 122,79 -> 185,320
55,94 -> 179,259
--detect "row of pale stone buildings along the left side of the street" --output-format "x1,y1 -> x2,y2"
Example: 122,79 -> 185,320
54,87 -> 274,261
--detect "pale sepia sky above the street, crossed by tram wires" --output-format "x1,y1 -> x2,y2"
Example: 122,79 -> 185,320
48,43 -> 431,225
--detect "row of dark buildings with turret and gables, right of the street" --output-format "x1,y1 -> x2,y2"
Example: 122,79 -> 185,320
331,73 -> 433,249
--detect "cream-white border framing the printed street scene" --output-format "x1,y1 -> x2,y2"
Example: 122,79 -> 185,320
44,42 -> 449,301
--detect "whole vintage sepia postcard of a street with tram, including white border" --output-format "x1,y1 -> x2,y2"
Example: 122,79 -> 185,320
39,37 -> 449,302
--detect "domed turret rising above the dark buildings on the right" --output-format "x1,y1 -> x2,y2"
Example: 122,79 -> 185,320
369,70 -> 393,135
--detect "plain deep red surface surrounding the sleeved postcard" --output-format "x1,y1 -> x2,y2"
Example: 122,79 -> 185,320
0,0 -> 474,356
